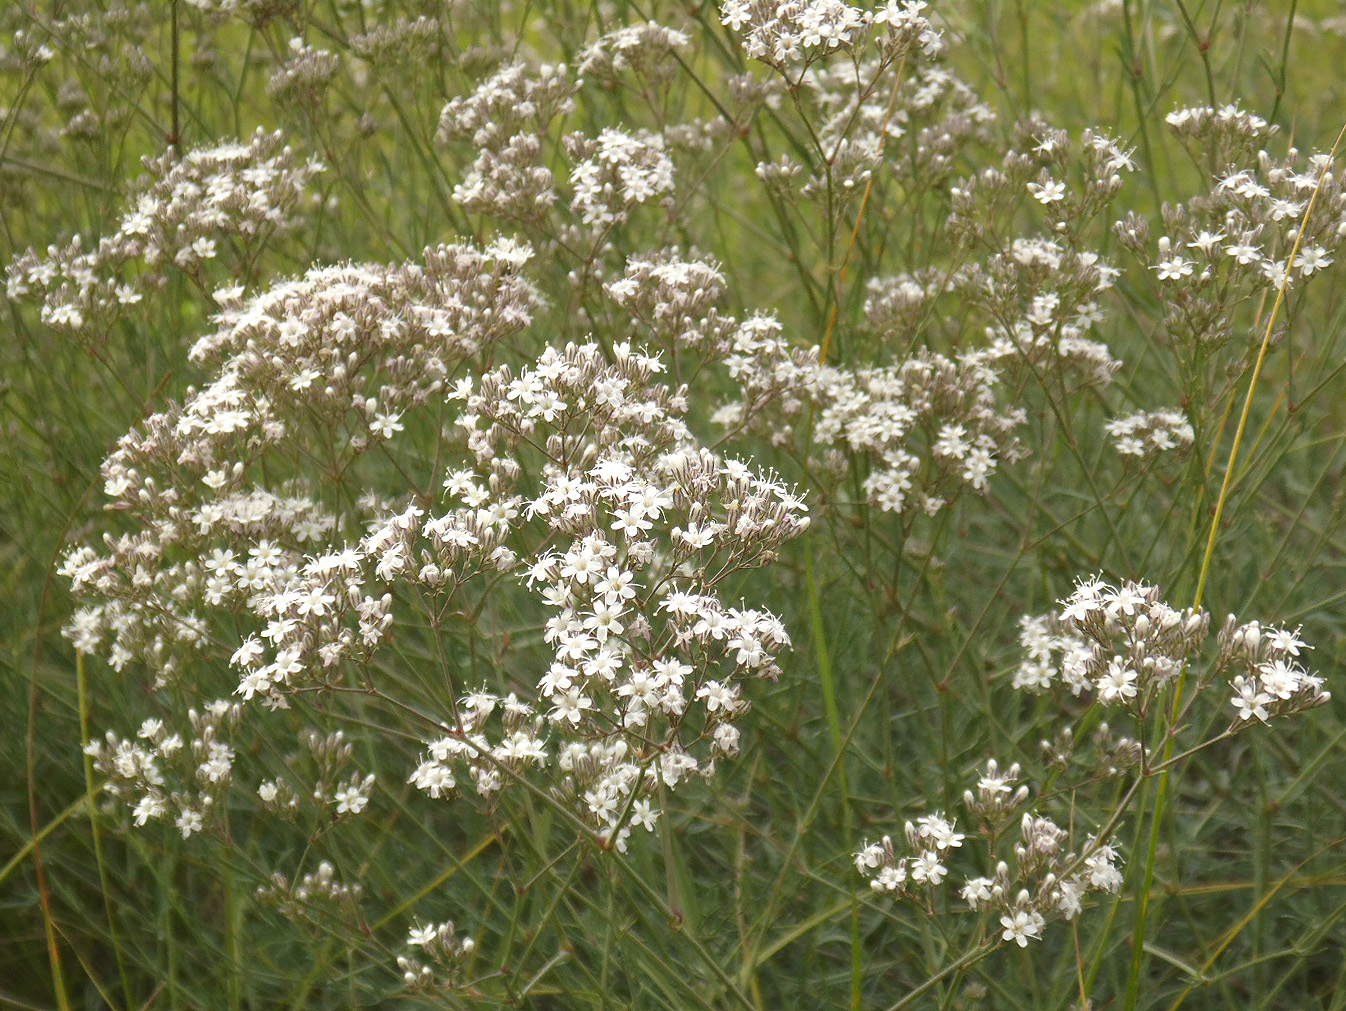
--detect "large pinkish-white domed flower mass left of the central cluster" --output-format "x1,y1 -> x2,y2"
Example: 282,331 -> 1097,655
62,241 -> 536,704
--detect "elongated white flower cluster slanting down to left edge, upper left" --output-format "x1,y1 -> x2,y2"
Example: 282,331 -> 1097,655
7,131 -> 322,338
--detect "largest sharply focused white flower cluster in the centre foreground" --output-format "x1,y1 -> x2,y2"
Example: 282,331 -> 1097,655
412,337 -> 808,847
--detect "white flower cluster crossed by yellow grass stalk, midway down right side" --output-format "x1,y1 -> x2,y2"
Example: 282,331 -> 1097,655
1014,579 -> 1330,723
